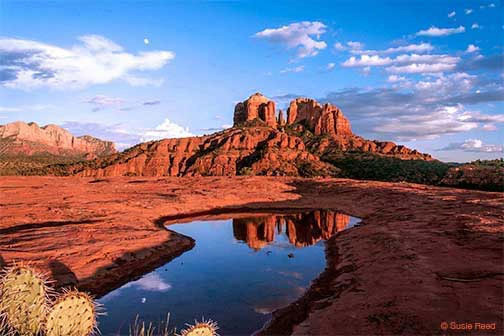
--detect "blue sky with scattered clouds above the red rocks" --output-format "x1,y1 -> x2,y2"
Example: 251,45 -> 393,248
0,0 -> 504,161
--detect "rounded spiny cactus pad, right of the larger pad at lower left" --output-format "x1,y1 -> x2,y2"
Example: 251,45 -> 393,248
44,291 -> 96,336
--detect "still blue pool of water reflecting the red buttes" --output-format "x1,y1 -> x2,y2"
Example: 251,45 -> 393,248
99,210 -> 359,335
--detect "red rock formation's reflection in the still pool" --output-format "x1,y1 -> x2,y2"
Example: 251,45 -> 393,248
233,210 -> 350,250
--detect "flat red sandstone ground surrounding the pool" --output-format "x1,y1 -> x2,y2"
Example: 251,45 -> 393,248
0,177 -> 504,335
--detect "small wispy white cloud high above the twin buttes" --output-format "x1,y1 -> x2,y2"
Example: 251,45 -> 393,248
254,21 -> 327,58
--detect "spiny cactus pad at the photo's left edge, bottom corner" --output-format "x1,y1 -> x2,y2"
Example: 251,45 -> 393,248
0,265 -> 48,336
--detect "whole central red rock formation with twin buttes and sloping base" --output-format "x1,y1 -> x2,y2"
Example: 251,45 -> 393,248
52,93 -> 431,177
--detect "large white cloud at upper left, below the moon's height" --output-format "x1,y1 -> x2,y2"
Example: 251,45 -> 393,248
0,35 -> 175,89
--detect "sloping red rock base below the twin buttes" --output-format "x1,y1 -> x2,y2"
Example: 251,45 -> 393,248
68,127 -> 336,177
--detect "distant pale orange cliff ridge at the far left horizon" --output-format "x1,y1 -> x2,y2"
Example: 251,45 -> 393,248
0,121 -> 116,158
